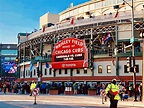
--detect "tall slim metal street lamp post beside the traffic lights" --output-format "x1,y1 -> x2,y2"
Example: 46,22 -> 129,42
123,0 -> 137,101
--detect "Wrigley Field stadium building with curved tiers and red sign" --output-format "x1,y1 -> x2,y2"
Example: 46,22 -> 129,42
17,0 -> 144,84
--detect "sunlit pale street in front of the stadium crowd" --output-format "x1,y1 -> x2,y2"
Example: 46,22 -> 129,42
0,93 -> 144,108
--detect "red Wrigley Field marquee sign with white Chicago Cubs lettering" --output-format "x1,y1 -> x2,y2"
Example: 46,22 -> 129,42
52,38 -> 88,69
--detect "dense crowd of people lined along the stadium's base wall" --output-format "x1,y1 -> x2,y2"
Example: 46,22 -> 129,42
0,81 -> 142,101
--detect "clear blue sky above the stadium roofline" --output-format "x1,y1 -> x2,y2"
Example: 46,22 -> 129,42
0,0 -> 89,43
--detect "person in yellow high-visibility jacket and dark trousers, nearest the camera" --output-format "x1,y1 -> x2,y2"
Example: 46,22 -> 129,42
106,79 -> 120,108
